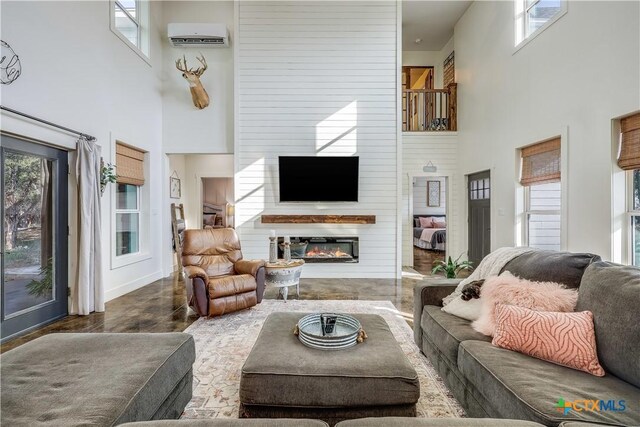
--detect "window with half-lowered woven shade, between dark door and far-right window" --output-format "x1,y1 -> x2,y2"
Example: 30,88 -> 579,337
520,138 -> 562,250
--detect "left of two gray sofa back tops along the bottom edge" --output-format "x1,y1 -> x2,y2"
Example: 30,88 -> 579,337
119,418 -> 329,427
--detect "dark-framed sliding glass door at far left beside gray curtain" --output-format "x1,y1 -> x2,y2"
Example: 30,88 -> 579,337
0,135 -> 68,341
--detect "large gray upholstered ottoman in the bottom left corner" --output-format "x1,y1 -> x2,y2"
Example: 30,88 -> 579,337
0,333 -> 195,427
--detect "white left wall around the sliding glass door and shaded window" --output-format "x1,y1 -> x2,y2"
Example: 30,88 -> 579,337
0,1 -> 164,299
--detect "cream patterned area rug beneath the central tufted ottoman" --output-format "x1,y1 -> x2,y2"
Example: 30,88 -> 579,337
182,300 -> 465,419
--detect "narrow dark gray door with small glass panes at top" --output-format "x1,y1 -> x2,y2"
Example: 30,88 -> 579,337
467,171 -> 491,266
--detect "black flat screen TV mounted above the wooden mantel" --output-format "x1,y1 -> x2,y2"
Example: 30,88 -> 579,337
278,156 -> 359,202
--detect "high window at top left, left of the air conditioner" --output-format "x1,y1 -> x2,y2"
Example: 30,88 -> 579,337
111,0 -> 149,57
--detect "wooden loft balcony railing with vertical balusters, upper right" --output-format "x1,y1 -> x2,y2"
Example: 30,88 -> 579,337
402,83 -> 458,132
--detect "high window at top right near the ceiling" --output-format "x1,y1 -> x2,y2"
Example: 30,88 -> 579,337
515,0 -> 567,46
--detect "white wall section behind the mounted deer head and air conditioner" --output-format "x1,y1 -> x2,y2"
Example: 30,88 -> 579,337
160,1 -> 234,153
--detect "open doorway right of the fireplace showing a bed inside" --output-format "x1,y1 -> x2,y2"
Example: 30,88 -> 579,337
411,176 -> 448,275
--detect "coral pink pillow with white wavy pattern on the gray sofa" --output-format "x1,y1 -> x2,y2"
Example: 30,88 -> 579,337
491,304 -> 605,377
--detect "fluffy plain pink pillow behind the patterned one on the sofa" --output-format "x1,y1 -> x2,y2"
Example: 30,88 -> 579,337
471,271 -> 578,336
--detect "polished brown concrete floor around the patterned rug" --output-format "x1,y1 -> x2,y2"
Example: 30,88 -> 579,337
0,270 -> 430,352
